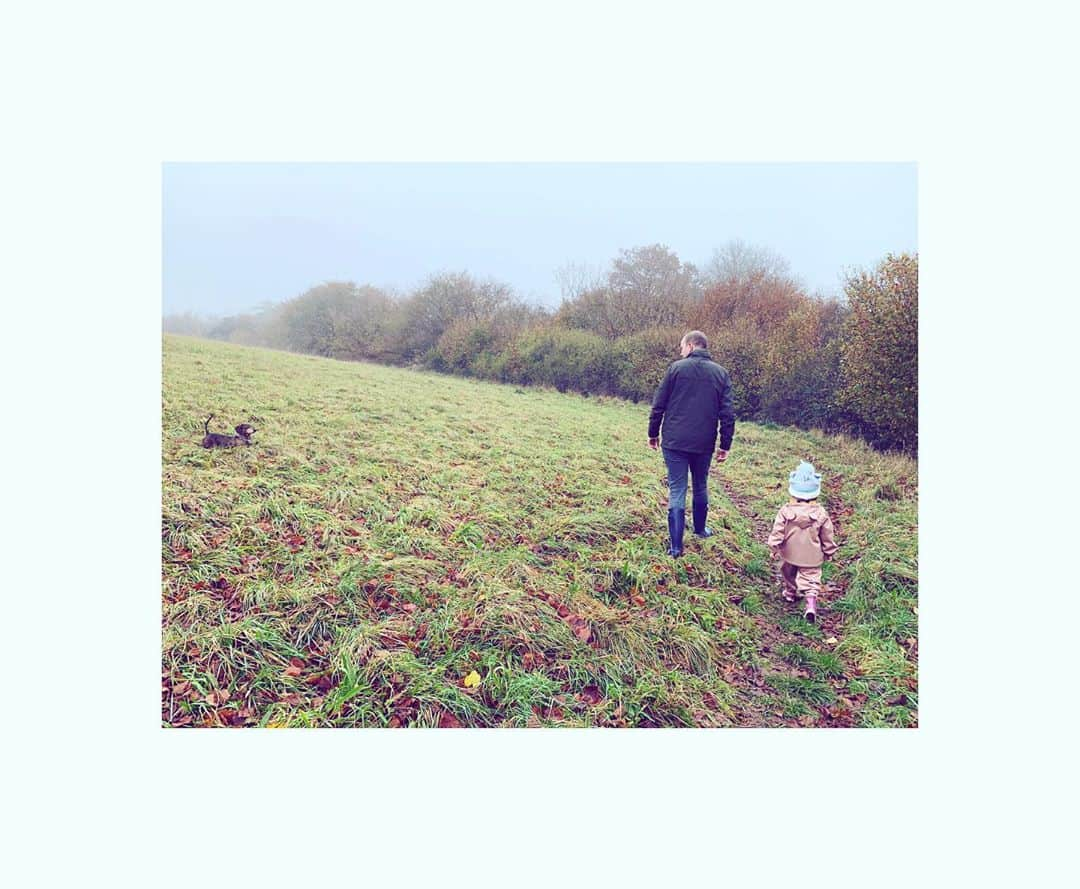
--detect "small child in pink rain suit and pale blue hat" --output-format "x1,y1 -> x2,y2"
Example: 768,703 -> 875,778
767,460 -> 837,622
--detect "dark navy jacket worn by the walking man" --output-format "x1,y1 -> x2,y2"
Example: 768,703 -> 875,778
649,349 -> 735,454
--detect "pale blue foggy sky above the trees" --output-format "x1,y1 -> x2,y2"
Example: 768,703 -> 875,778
162,163 -> 918,314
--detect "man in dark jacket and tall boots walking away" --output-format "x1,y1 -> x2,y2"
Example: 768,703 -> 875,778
649,331 -> 735,556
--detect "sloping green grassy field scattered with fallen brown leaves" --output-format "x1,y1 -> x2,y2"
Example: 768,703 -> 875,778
162,337 -> 918,727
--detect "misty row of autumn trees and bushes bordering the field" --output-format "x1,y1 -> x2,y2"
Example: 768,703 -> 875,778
163,241 -> 918,453
